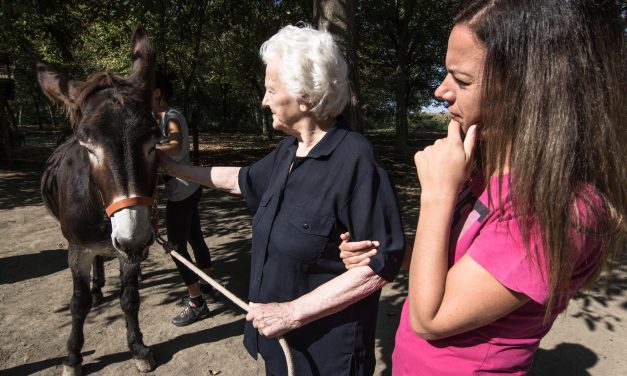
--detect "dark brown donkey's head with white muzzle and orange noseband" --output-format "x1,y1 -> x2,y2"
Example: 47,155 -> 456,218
37,28 -> 159,262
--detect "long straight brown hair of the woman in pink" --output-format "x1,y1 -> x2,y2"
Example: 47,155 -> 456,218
455,0 -> 627,318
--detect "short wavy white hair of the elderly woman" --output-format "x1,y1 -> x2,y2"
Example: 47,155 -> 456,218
259,25 -> 349,119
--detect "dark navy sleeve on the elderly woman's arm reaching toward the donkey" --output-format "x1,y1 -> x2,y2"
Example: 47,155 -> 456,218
238,144 -> 281,213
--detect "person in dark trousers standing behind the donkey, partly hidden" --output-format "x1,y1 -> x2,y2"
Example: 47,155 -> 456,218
152,71 -> 216,326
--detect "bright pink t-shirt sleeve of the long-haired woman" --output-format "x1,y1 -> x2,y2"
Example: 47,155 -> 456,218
468,218 -> 549,304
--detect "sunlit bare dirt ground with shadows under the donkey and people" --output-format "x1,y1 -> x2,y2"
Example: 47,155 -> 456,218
0,139 -> 627,376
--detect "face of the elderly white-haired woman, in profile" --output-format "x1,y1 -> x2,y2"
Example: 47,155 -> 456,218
261,59 -> 306,133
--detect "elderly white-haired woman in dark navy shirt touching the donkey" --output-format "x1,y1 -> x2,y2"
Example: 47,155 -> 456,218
160,26 -> 404,375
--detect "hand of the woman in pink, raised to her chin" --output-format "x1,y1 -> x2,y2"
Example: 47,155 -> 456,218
414,120 -> 477,197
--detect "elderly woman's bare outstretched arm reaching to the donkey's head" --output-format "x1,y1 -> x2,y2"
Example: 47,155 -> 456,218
157,151 -> 242,194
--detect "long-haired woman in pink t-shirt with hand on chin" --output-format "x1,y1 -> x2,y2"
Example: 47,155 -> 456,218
341,0 -> 627,376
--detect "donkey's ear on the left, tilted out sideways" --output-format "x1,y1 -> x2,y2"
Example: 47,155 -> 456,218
37,63 -> 85,108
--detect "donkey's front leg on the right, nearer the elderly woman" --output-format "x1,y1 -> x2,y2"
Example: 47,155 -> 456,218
120,258 -> 155,372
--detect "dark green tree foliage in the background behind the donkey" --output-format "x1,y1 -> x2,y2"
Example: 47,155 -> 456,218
0,0 -> 451,132
